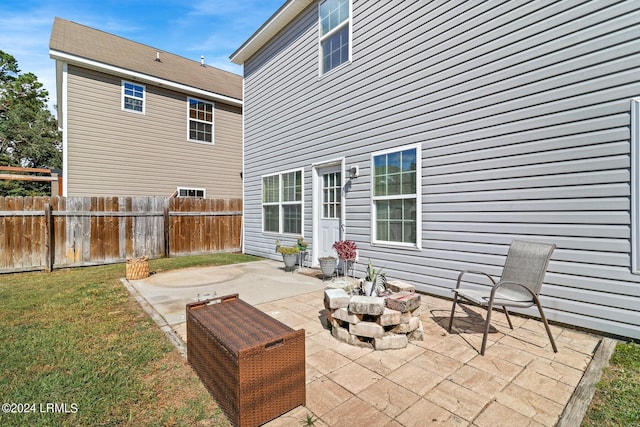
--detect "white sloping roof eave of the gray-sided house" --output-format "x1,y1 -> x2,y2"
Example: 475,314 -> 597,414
229,0 -> 314,65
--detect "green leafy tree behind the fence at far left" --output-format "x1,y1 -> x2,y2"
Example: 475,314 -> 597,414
0,50 -> 62,196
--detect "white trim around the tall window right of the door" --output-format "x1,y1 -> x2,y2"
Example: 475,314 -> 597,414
370,144 -> 422,249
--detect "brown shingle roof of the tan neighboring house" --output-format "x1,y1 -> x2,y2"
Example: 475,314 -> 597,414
49,17 -> 242,100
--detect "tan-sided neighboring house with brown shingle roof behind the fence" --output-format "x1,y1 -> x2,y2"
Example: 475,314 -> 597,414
49,18 -> 242,198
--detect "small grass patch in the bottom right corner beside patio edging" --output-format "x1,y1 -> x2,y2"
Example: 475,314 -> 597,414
582,343 -> 640,427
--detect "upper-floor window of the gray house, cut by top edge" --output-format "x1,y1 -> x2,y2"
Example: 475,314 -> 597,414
319,0 -> 351,74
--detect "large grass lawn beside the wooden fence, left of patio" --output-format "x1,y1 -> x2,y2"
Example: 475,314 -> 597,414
0,254 -> 256,426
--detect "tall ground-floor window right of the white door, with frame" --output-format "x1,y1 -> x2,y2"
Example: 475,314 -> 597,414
372,147 -> 420,247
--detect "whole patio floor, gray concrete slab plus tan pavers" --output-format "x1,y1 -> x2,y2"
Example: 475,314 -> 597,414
124,261 -> 611,427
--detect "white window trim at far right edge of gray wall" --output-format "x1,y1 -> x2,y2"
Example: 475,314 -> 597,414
631,98 -> 640,274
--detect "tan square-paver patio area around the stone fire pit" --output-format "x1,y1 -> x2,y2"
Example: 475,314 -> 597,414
251,291 -> 601,427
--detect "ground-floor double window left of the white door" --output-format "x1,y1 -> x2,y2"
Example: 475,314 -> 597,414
262,170 -> 302,234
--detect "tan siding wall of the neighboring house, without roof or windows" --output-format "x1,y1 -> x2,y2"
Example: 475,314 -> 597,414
67,65 -> 242,198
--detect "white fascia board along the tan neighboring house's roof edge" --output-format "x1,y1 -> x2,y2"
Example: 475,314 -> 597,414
49,49 -> 243,107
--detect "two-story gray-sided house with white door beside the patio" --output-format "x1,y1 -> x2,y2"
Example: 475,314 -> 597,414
231,0 -> 640,339
